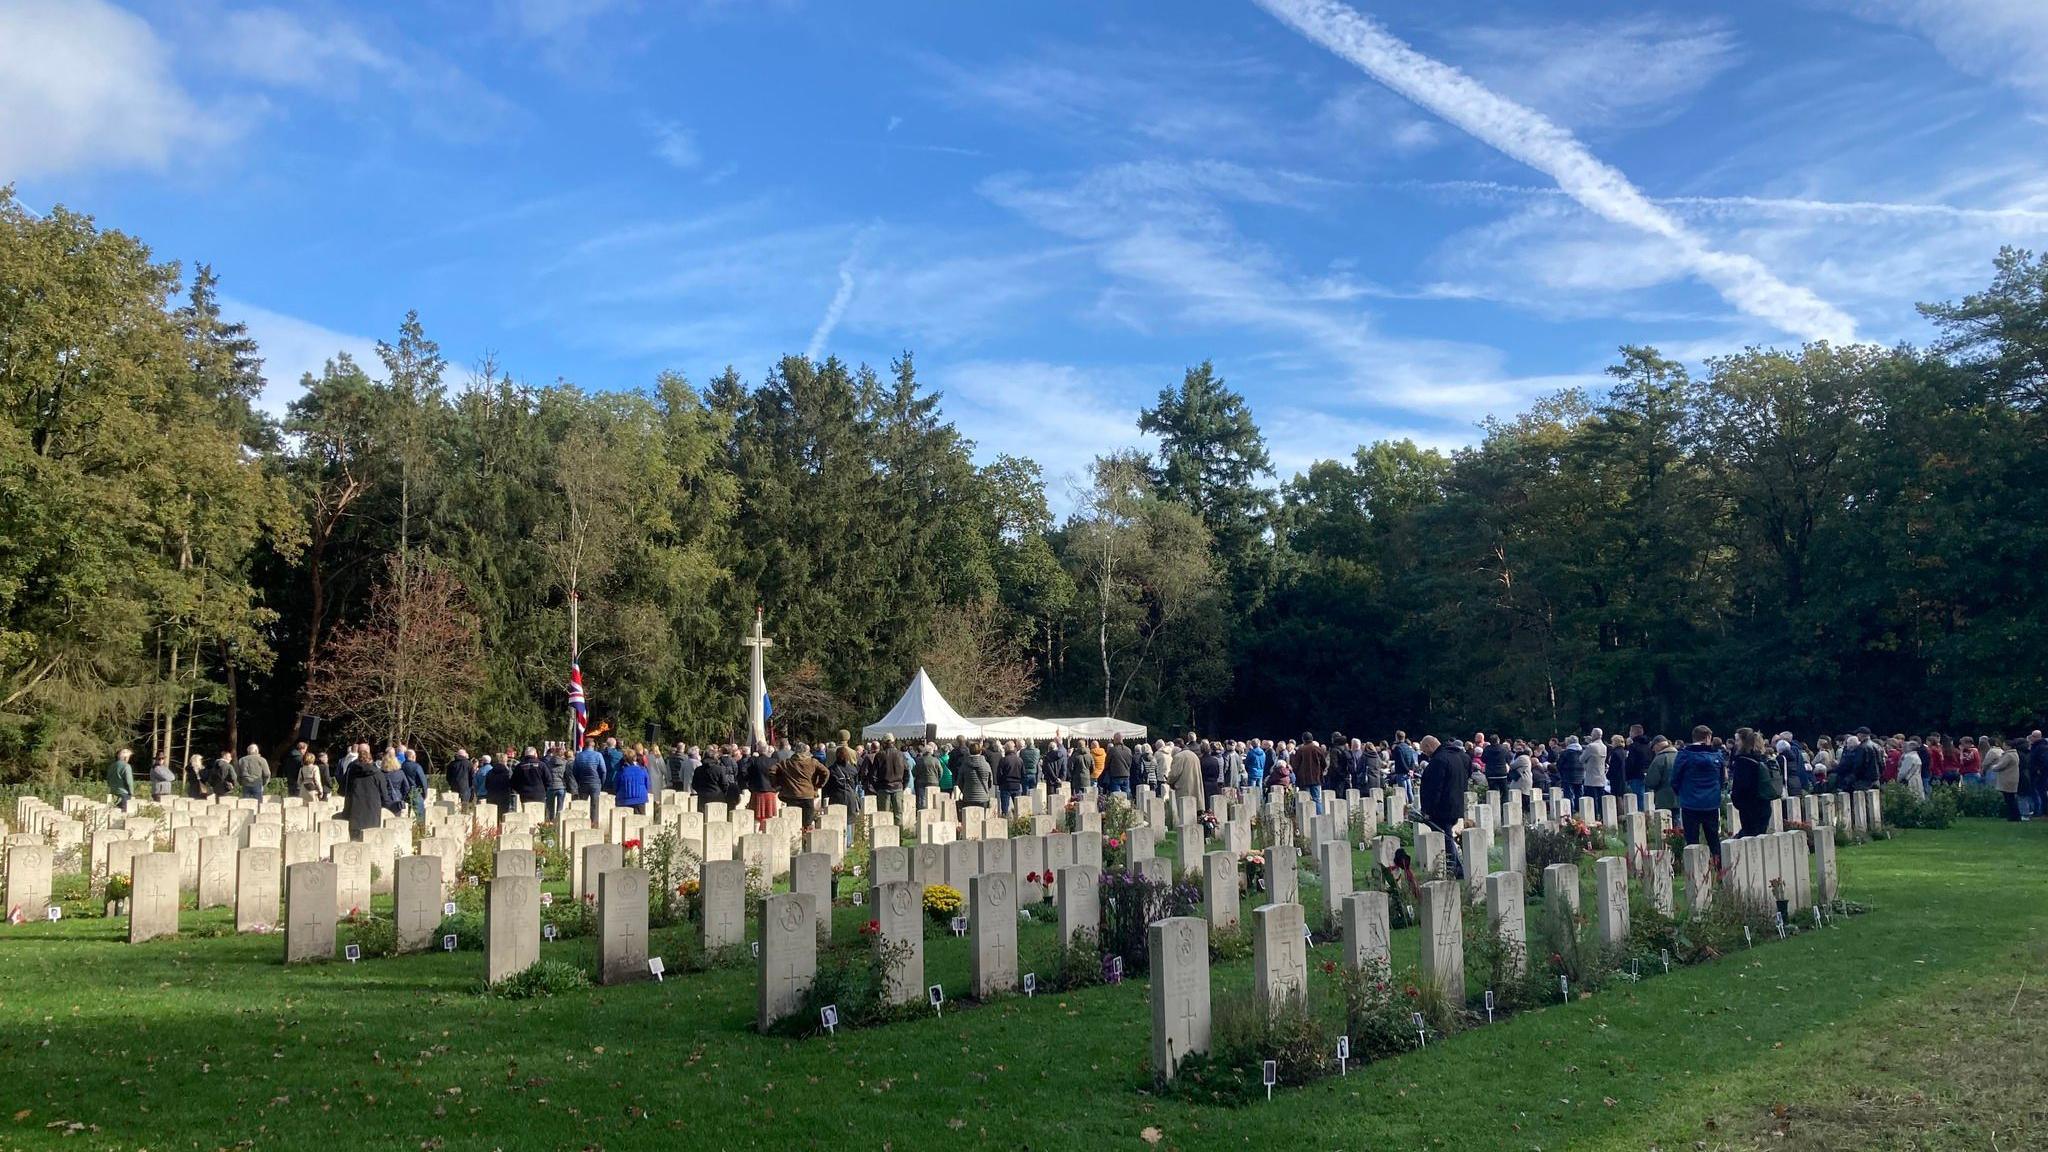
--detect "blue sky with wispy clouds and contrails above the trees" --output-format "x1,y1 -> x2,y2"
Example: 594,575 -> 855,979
0,0 -> 2048,487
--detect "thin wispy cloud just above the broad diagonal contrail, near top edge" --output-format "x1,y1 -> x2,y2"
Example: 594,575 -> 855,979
1450,16 -> 1739,127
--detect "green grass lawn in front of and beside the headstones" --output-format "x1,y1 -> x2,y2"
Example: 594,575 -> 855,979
0,820 -> 2048,1152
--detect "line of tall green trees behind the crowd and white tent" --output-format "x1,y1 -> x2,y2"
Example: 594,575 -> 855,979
0,193 -> 2048,779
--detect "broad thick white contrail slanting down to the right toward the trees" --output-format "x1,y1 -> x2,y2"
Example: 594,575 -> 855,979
1255,0 -> 1855,342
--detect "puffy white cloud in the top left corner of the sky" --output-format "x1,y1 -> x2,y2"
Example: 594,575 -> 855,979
0,0 -> 238,178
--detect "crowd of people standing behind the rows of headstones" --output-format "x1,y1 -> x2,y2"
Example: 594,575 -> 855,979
106,724 -> 2048,859
